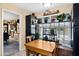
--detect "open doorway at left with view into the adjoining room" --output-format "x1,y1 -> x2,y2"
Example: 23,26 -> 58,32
2,9 -> 20,56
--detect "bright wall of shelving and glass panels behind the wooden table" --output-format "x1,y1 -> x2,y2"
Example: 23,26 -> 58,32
28,13 -> 73,47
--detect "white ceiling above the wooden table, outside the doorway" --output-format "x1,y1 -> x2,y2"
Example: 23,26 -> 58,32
13,3 -> 68,12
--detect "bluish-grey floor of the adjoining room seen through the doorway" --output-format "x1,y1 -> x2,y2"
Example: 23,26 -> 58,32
4,40 -> 19,56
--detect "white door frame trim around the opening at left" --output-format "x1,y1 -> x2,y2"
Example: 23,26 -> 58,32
1,8 -> 21,56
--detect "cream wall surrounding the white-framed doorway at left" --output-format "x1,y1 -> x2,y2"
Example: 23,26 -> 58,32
0,3 -> 29,55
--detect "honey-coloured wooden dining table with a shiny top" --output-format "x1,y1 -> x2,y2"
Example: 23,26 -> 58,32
25,39 -> 56,56
